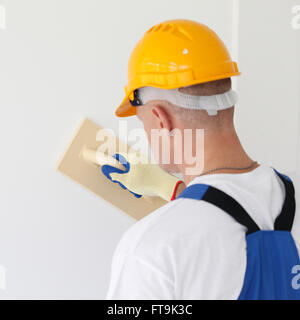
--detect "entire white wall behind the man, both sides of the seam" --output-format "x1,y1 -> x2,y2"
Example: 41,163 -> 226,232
0,0 -> 300,299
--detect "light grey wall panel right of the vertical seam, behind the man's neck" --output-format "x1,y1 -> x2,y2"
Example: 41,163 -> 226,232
236,0 -> 300,172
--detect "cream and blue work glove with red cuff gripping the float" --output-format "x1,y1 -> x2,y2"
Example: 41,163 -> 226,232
101,153 -> 183,201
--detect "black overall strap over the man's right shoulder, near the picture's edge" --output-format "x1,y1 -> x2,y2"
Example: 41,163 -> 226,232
273,168 -> 296,231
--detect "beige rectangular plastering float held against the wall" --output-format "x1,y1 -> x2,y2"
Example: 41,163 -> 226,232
57,119 -> 167,220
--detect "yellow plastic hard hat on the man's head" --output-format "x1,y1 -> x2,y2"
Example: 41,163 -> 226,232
115,19 -> 240,117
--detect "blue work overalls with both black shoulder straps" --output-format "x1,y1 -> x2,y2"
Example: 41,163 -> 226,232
177,169 -> 300,300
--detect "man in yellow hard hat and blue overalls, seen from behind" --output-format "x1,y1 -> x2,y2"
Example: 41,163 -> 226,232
102,20 -> 300,299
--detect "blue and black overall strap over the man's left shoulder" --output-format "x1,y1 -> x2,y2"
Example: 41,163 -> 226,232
177,184 -> 259,235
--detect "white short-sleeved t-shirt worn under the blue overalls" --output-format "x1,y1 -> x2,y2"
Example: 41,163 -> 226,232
106,165 -> 300,300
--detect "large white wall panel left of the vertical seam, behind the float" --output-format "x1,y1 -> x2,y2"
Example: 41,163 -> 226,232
0,0 -> 232,299
